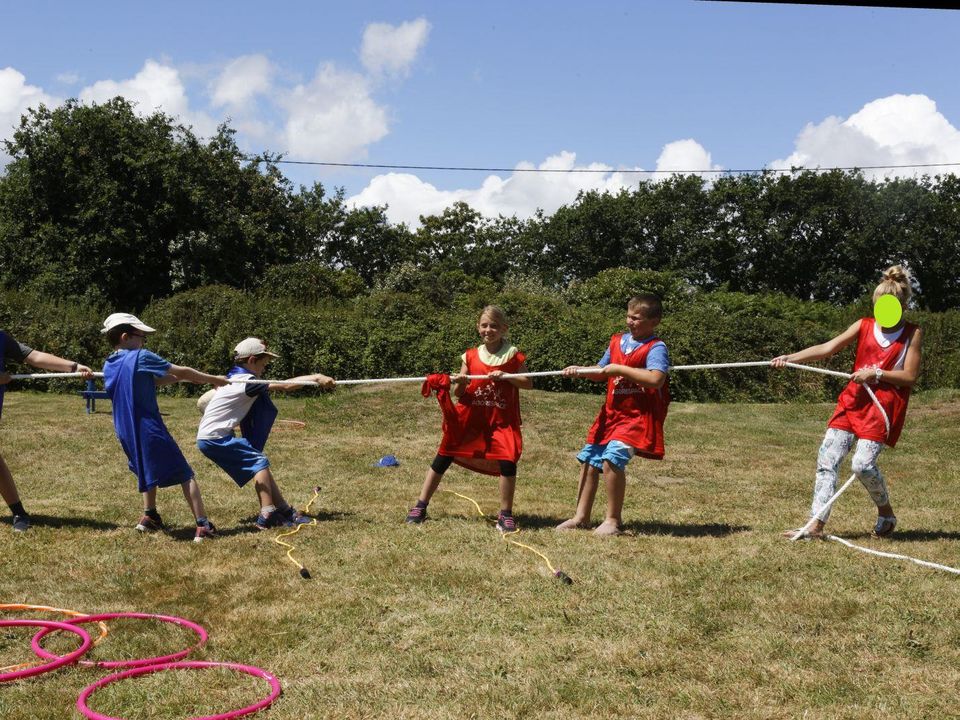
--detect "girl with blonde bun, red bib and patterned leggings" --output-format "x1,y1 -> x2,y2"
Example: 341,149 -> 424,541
771,265 -> 922,537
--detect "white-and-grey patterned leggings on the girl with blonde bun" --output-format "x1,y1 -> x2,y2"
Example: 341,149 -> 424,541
810,428 -> 890,521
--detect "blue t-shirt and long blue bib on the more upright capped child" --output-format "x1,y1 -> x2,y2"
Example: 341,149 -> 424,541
103,350 -> 193,492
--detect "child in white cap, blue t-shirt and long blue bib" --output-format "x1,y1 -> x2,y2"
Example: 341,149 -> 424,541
100,313 -> 227,542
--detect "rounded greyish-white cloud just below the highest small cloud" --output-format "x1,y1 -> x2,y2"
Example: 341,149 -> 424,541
281,63 -> 389,162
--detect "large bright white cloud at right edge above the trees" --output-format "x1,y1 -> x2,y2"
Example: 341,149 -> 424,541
770,95 -> 960,177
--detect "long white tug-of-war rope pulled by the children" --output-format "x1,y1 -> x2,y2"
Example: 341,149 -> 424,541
11,360 -> 960,575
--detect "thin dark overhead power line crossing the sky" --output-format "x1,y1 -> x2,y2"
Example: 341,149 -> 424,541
247,156 -> 960,175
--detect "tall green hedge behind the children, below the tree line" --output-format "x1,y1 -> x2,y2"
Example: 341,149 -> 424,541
0,266 -> 960,402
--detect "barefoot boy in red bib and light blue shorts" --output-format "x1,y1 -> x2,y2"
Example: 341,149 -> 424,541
557,295 -> 670,536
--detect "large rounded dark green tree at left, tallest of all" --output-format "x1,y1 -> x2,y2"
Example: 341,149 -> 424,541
0,98 -> 304,309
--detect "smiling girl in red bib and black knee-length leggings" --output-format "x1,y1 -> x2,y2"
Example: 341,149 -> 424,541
407,305 -> 533,532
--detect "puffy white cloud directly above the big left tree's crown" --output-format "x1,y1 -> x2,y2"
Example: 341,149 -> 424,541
79,60 -> 217,136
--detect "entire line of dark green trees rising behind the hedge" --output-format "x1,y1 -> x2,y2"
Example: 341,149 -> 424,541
0,98 -> 960,311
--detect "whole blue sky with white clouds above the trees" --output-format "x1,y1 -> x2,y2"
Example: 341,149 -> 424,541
0,0 -> 960,224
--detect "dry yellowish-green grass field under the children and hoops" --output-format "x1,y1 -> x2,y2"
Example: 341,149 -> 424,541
0,385 -> 960,720
